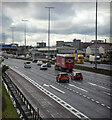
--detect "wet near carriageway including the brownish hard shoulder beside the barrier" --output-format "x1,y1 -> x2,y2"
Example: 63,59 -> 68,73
4,59 -> 112,120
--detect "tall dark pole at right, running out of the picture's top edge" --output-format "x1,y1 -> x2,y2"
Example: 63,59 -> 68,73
95,0 -> 97,69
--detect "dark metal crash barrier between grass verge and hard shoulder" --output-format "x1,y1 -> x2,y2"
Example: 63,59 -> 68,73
2,73 -> 41,120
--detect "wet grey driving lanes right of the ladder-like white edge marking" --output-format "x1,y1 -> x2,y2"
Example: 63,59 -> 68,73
4,59 -> 112,120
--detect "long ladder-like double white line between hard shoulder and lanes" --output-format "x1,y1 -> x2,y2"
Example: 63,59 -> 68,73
10,67 -> 90,120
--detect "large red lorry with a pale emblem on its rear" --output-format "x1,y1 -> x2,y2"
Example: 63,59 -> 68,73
55,54 -> 74,72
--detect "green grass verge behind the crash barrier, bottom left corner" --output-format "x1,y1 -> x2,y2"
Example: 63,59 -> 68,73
2,83 -> 20,120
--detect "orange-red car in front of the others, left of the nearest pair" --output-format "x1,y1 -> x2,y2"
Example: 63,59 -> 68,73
56,72 -> 69,83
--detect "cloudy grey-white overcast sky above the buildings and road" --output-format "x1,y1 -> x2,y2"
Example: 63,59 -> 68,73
0,1 -> 110,46
